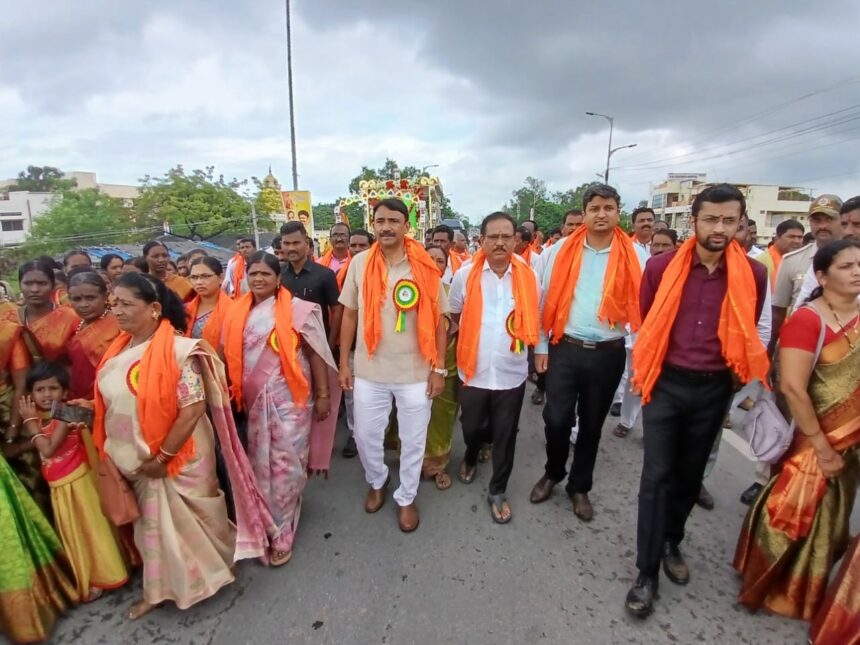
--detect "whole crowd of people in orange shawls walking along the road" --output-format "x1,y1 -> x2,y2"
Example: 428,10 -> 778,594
0,184 -> 860,645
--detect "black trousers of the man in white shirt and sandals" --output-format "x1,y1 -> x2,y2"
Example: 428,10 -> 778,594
460,383 -> 526,495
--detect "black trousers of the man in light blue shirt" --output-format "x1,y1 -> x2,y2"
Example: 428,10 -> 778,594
543,341 -> 627,494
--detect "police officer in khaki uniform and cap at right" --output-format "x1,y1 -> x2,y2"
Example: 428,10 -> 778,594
769,195 -> 842,352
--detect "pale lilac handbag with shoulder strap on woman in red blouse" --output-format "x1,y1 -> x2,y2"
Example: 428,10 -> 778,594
743,305 -> 827,464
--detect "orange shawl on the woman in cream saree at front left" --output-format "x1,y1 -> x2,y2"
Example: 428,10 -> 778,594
93,318 -> 194,476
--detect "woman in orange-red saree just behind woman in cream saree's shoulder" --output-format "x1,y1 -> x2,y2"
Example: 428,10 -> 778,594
69,271 -> 120,400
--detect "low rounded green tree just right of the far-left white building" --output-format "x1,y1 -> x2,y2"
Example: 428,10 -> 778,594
17,188 -> 139,257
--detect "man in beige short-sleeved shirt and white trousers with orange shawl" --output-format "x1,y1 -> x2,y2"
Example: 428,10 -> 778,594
340,199 -> 448,532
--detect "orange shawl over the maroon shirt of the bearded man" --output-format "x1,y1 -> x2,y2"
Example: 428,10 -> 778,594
632,237 -> 770,404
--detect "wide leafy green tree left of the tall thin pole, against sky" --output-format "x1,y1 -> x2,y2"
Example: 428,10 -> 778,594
135,165 -> 262,240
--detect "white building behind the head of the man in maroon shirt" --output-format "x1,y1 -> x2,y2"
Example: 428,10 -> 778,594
648,173 -> 812,245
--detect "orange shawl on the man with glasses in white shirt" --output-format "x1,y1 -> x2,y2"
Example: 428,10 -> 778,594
457,251 -> 539,383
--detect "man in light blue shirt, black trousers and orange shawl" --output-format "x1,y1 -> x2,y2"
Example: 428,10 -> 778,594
530,184 -> 642,522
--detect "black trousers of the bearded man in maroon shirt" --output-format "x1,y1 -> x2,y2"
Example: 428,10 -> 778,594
636,365 -> 733,576
